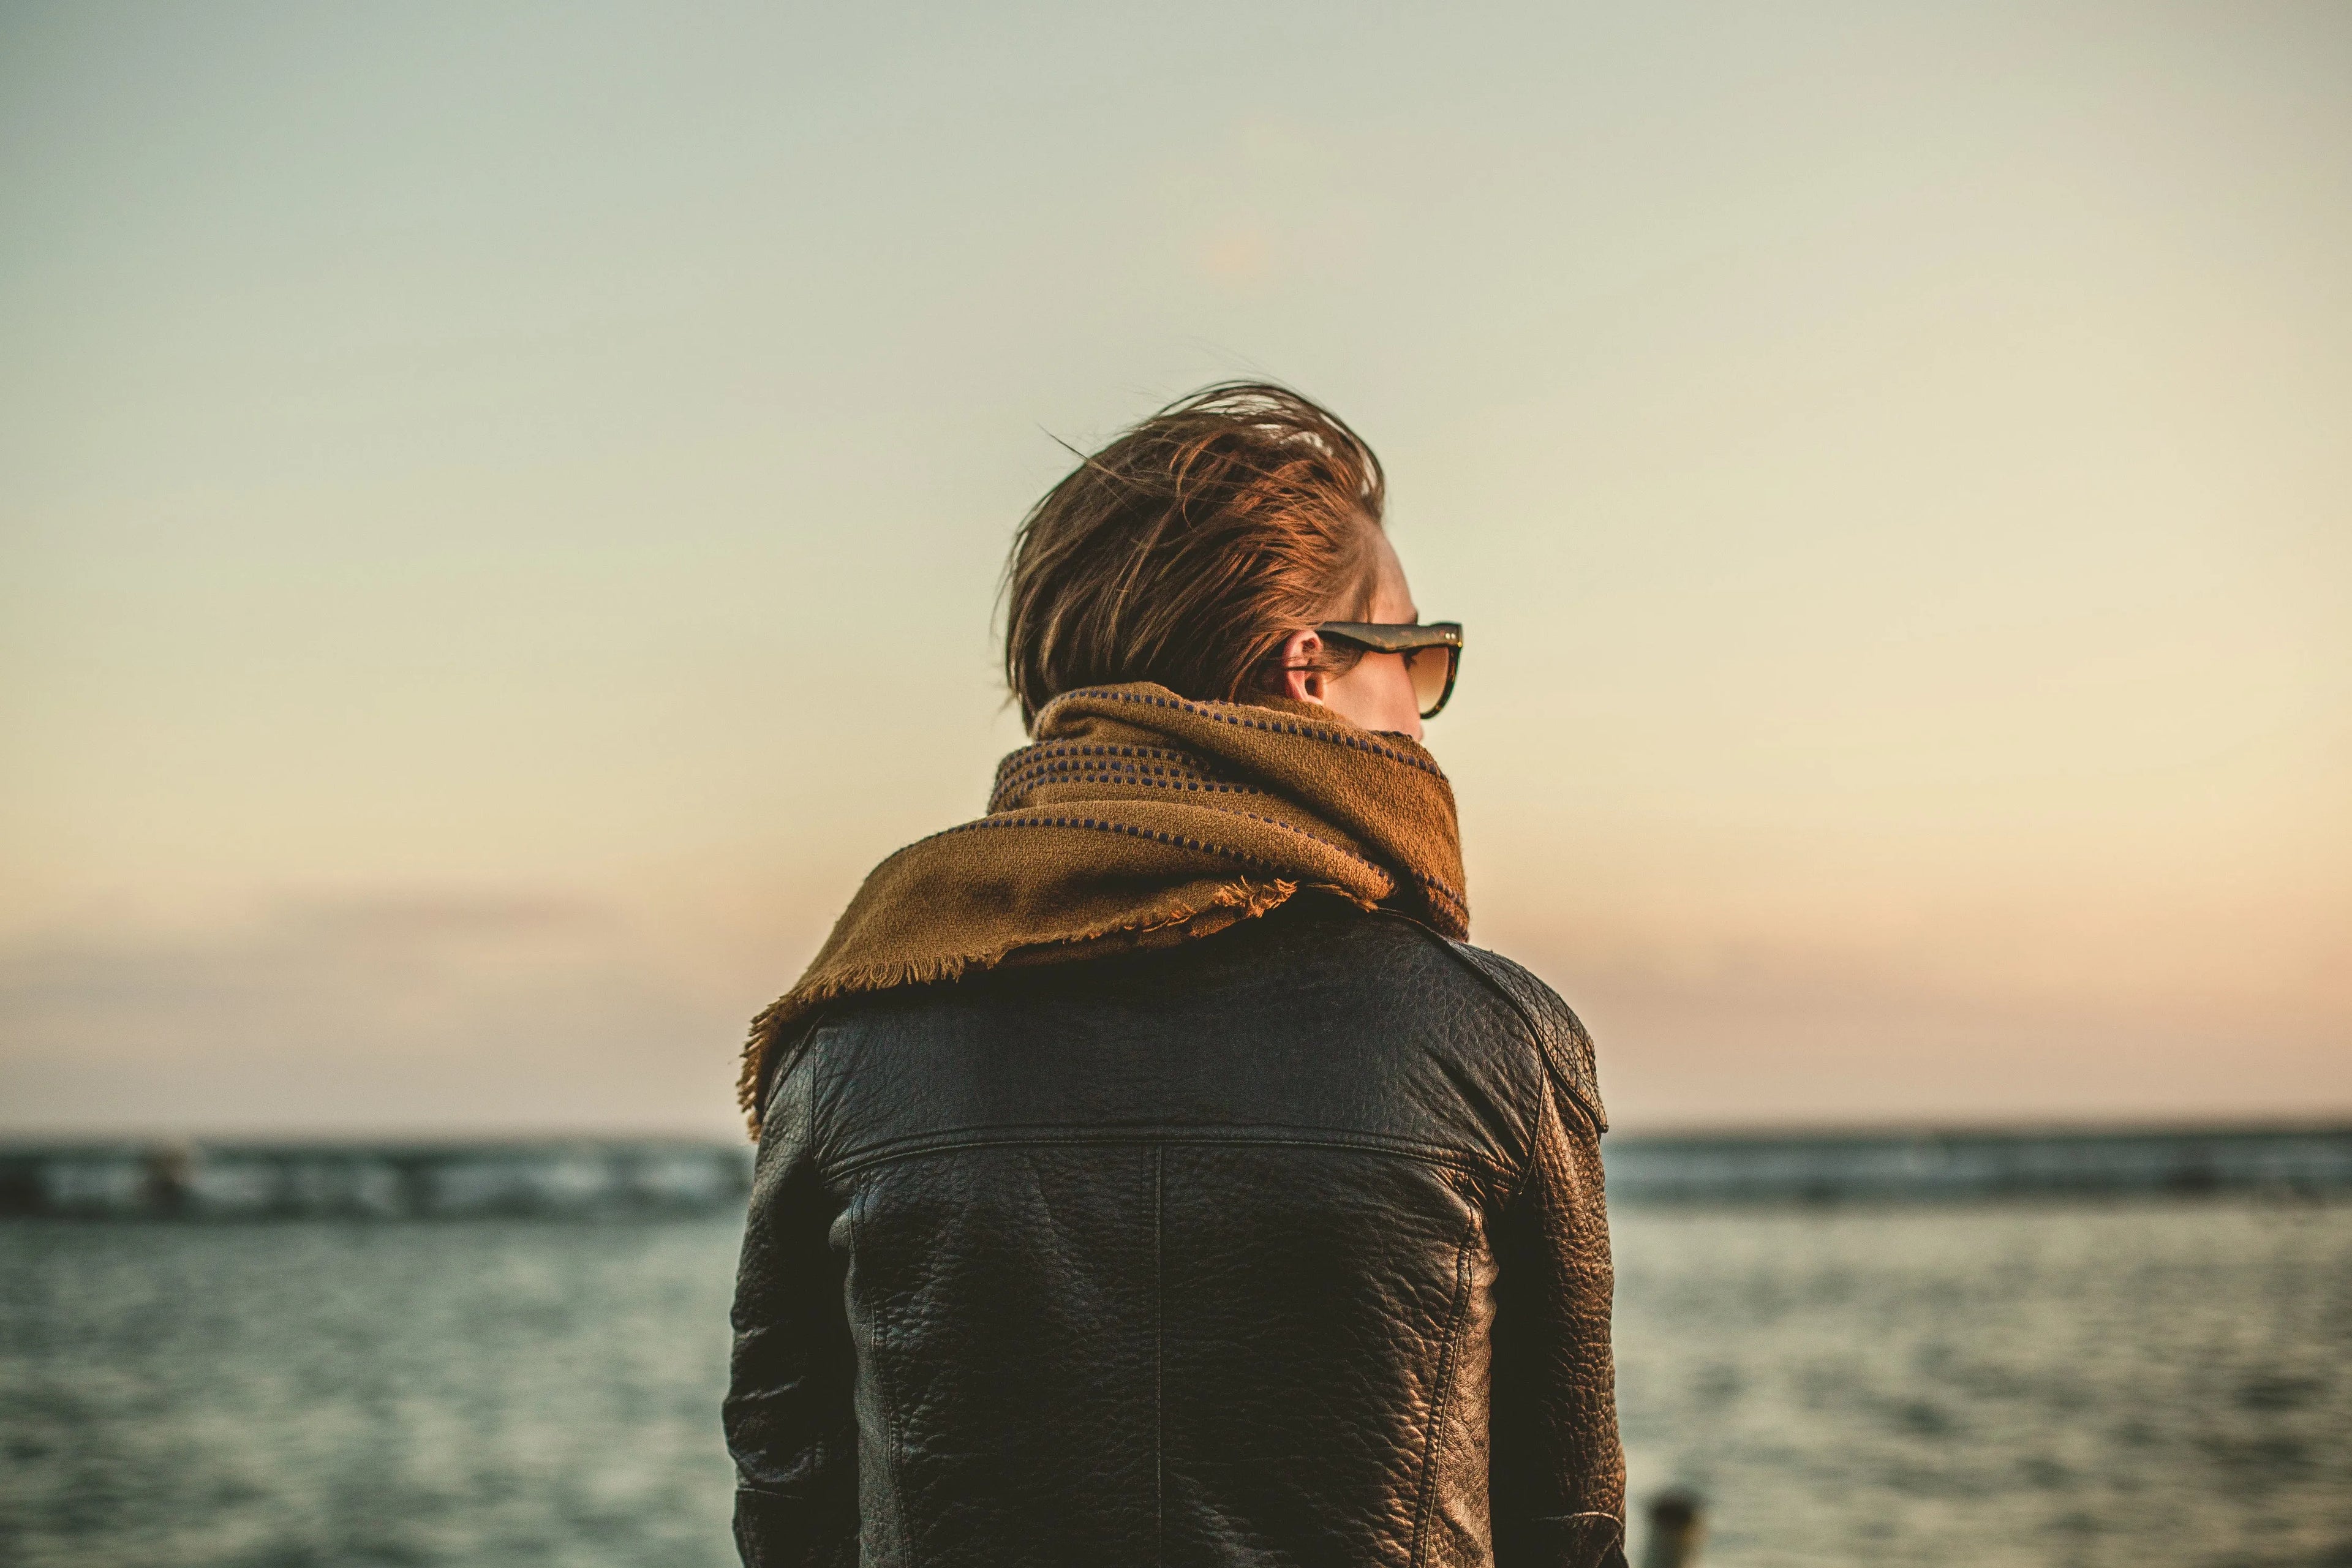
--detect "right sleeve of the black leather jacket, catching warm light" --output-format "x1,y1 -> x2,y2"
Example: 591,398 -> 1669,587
1489,966 -> 1625,1568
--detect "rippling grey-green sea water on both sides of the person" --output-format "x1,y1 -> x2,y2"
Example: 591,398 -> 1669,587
0,1201 -> 2352,1568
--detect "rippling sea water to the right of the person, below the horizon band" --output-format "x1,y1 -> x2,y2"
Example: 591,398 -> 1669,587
1613,1201 -> 2352,1568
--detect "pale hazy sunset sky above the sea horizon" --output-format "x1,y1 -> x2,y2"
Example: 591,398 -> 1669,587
0,0 -> 2352,1136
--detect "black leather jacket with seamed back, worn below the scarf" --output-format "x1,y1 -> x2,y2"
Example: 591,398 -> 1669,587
727,895 -> 1625,1568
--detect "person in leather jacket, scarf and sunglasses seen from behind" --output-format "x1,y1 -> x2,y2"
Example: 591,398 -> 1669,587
725,383 -> 1625,1568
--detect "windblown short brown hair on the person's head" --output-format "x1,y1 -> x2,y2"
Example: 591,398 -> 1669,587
1005,381 -> 1385,724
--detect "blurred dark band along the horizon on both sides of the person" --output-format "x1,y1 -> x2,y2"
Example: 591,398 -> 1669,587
0,1126 -> 2352,1220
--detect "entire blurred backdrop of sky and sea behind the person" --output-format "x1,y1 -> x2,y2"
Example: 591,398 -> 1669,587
0,0 -> 2352,1566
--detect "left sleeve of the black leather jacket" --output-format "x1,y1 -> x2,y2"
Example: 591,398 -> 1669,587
727,1053 -> 859,1568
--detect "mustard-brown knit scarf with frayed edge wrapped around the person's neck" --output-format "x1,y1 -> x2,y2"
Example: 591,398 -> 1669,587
739,684 -> 1470,1138
